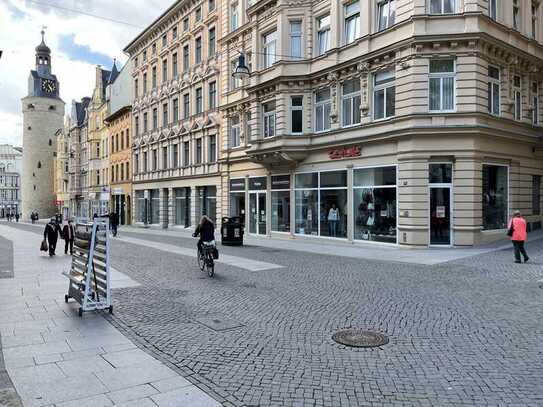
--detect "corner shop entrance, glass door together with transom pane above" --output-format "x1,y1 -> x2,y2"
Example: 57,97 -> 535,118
429,163 -> 453,246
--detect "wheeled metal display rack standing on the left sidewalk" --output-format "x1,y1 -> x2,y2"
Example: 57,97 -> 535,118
64,217 -> 113,317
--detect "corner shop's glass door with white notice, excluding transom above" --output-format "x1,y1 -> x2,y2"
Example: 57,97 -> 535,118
430,187 -> 451,246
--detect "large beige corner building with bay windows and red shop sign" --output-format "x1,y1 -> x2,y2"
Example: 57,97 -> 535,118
221,0 -> 543,247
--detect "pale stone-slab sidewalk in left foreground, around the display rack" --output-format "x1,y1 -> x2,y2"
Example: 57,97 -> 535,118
0,225 -> 220,407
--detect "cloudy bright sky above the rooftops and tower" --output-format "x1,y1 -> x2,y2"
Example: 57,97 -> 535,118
0,0 -> 174,146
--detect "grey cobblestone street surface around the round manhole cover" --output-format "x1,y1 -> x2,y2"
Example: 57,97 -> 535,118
4,226 -> 543,406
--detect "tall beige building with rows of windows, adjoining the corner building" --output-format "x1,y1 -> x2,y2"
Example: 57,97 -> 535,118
125,0 -> 222,228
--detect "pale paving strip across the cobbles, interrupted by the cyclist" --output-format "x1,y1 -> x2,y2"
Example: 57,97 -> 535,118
115,237 -> 284,271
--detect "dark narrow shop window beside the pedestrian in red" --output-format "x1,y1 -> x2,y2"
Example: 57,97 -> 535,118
483,164 -> 509,230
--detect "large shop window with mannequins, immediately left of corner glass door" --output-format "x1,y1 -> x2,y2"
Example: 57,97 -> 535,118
353,167 -> 397,243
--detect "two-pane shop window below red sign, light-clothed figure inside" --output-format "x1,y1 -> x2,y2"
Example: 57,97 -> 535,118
295,171 -> 347,238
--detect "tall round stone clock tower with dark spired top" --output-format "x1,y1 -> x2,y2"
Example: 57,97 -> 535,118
21,31 -> 64,220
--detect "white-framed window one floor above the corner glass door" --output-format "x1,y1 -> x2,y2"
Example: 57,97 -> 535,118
429,59 -> 456,112
